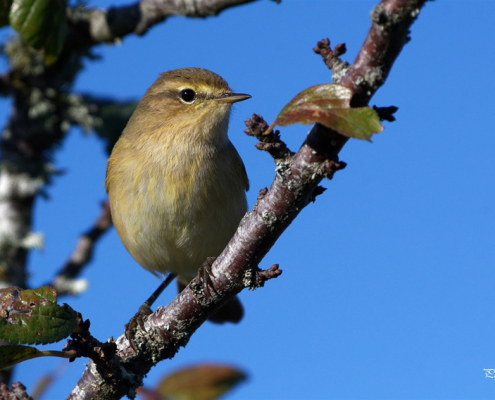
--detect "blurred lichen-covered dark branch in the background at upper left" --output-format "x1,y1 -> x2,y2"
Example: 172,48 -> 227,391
0,0 -> 268,390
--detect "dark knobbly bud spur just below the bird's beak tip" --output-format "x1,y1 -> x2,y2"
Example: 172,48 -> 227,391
244,114 -> 294,163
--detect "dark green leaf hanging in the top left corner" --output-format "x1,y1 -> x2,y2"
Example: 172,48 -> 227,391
10,0 -> 67,65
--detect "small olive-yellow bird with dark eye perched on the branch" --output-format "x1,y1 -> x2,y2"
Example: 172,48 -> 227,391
106,68 -> 251,322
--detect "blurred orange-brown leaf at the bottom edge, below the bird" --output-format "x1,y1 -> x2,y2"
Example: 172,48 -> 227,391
156,364 -> 246,400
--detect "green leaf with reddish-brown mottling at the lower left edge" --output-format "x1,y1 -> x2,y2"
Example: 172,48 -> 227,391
0,286 -> 77,344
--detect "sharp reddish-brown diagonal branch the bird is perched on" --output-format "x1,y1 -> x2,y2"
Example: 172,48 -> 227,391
69,0 -> 425,399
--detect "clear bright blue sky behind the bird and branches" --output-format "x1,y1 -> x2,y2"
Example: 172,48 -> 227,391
0,0 -> 495,400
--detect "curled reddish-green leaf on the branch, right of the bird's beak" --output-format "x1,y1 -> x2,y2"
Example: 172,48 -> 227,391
275,84 -> 383,140
